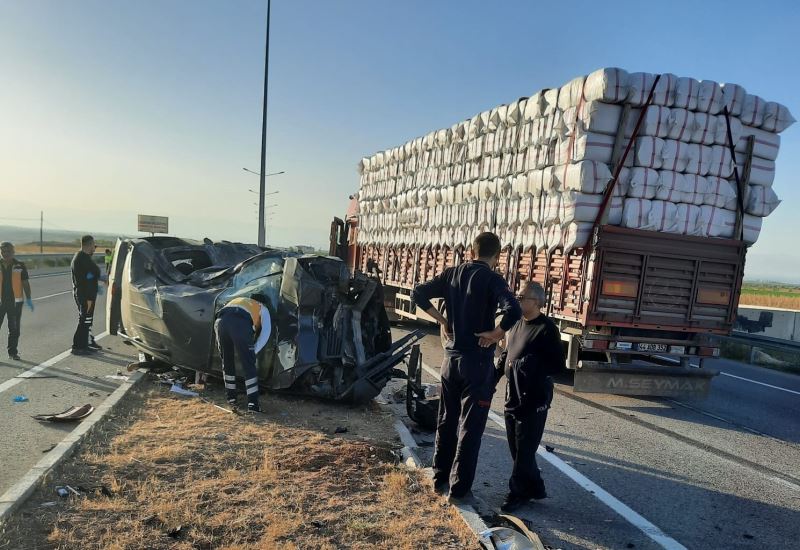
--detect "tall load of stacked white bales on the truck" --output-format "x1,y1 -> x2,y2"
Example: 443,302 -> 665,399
358,68 -> 794,251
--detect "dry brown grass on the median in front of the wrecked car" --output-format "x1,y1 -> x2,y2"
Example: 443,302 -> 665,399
0,384 -> 476,549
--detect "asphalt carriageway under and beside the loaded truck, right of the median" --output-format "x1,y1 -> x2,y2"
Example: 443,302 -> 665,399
395,328 -> 800,549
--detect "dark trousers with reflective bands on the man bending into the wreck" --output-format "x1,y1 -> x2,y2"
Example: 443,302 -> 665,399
214,307 -> 258,404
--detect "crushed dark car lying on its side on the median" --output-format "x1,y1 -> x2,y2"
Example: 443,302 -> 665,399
113,237 -> 421,403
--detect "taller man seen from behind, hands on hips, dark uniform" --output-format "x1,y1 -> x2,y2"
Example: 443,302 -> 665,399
412,232 -> 521,502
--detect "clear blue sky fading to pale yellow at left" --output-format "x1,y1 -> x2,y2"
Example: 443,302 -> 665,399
0,0 -> 800,282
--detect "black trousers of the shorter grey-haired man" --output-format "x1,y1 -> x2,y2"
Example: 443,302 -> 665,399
505,382 -> 553,498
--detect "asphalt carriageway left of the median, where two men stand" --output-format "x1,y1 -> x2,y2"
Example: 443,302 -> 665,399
0,274 -> 134,494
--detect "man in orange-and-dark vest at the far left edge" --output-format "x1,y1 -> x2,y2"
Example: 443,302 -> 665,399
0,241 -> 33,361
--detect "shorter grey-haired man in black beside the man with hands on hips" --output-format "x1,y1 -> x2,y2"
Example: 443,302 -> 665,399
495,282 -> 565,512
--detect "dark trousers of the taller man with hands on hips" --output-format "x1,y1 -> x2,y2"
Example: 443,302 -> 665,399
433,356 -> 494,498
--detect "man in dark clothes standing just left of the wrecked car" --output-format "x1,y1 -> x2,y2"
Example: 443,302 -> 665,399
71,235 -> 101,355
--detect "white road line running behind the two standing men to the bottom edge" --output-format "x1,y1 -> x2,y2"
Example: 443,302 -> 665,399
422,363 -> 687,550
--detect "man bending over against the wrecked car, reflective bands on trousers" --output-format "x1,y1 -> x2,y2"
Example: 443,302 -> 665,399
214,294 -> 272,412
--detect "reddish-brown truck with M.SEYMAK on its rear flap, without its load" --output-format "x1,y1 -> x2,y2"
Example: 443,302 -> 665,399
330,79 -> 772,397
